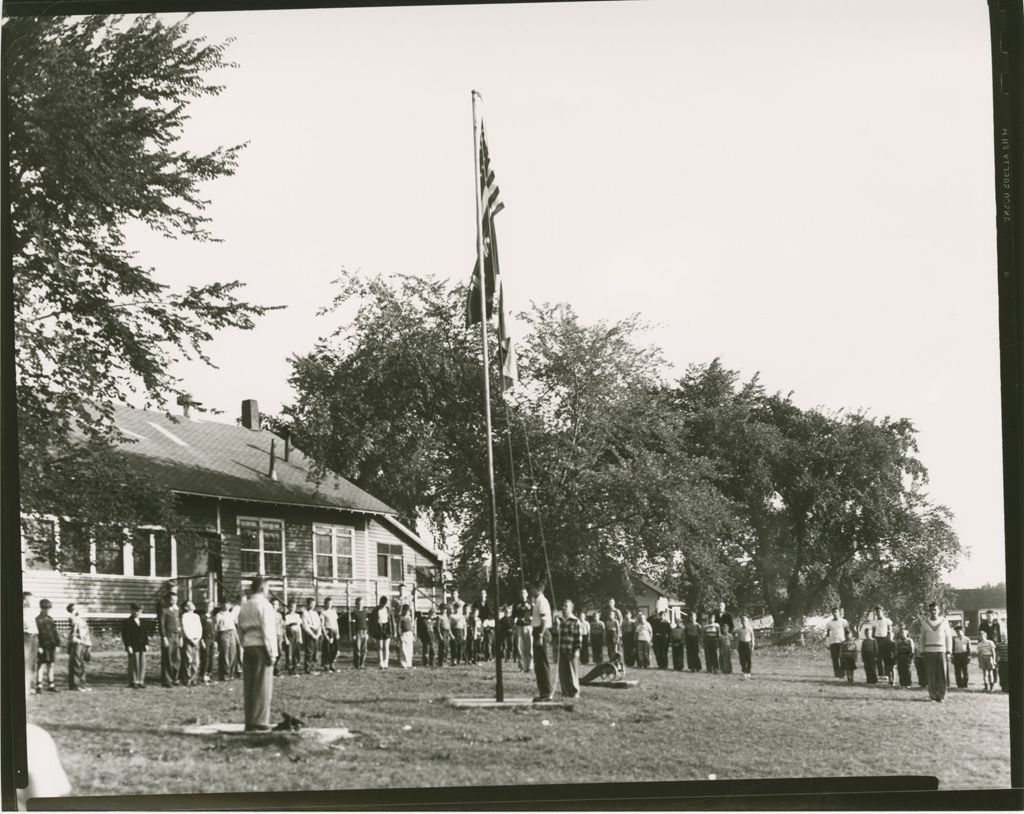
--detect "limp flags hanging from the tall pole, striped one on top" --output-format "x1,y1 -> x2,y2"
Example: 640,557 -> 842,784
466,123 -> 518,387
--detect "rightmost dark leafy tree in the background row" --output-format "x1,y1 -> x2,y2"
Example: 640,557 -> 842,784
674,360 -> 961,624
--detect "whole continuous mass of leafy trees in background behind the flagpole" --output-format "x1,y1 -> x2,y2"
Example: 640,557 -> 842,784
283,274 -> 959,622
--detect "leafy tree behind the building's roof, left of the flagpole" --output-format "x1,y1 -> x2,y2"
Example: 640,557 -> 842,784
282,272 -> 485,539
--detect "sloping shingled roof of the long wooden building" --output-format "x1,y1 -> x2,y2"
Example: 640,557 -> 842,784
115,406 -> 398,516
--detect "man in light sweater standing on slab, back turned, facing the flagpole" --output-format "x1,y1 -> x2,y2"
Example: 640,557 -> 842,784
239,576 -> 278,732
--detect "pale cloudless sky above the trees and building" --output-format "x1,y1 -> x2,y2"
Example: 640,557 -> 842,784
123,0 -> 1005,587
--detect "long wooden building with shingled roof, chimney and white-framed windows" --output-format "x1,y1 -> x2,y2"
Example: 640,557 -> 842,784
22,400 -> 442,618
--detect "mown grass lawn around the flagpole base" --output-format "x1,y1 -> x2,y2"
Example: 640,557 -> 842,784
29,650 -> 1010,795
